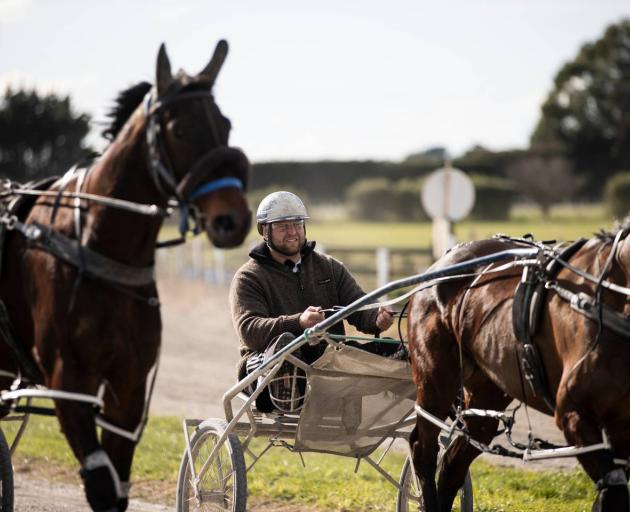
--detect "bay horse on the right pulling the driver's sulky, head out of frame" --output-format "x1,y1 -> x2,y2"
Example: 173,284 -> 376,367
408,222 -> 630,512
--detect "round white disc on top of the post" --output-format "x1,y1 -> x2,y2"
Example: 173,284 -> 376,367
420,167 -> 475,221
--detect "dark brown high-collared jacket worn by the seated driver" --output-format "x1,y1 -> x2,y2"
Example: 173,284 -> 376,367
230,242 -> 378,355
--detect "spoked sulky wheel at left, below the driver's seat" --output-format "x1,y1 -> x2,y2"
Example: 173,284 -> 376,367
176,418 -> 247,512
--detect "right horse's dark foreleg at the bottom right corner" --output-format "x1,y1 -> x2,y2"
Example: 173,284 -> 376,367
558,408 -> 630,512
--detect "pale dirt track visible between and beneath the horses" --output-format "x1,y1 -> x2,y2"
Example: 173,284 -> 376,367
16,280 -> 576,512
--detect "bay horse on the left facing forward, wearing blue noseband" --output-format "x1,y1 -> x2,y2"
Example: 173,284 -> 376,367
0,41 -> 251,511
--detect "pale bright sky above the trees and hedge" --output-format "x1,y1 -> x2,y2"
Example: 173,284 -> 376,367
0,0 -> 630,161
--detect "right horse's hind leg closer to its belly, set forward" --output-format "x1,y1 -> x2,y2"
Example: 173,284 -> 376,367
438,370 -> 512,510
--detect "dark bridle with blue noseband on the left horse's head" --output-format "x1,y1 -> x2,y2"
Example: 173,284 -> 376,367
144,90 -> 249,236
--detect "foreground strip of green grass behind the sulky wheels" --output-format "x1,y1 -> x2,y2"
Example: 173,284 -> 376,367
3,417 -> 594,512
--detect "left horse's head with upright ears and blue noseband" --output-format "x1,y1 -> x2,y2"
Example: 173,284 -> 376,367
144,40 -> 251,247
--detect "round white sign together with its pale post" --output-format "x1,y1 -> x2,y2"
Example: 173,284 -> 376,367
420,161 -> 475,259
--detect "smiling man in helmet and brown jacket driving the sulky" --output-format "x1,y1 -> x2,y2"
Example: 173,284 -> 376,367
230,191 -> 393,408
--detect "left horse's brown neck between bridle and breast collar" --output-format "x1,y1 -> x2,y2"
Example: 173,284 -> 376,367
82,108 -> 167,266
